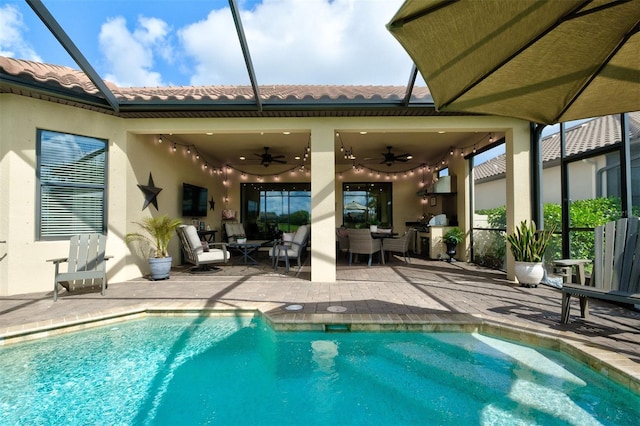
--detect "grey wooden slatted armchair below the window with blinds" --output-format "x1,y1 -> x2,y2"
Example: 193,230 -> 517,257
47,234 -> 112,302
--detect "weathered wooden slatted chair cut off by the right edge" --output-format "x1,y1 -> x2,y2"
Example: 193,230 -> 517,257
560,217 -> 640,324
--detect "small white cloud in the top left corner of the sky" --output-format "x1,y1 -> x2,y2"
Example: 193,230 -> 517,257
0,4 -> 42,62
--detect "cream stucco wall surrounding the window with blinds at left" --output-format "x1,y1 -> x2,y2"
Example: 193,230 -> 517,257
0,95 -> 126,295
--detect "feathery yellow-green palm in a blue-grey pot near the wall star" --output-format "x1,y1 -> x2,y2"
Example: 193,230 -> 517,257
124,215 -> 182,280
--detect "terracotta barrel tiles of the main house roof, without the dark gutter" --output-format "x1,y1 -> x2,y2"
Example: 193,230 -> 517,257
0,56 -> 433,109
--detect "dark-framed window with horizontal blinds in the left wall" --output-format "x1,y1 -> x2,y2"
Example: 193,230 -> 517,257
37,130 -> 107,239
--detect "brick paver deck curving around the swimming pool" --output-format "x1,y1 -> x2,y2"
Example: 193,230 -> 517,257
0,257 -> 640,393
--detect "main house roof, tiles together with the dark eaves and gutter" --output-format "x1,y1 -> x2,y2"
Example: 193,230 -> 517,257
0,56 -> 456,117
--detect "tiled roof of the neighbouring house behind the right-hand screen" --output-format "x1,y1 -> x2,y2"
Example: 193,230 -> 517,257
473,111 -> 640,183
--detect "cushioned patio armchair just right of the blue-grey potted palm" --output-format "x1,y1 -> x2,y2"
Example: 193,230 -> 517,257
176,225 -> 231,272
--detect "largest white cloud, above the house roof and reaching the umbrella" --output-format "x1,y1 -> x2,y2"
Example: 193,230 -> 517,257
178,0 -> 411,85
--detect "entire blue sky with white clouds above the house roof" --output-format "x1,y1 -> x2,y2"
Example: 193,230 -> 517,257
0,0 -> 424,86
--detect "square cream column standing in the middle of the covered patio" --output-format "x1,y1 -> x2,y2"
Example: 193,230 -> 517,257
311,126 -> 336,282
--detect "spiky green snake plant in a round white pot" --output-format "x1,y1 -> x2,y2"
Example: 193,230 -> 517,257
506,220 -> 555,287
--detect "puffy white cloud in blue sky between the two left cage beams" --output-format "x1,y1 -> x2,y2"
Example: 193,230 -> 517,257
99,17 -> 173,87
